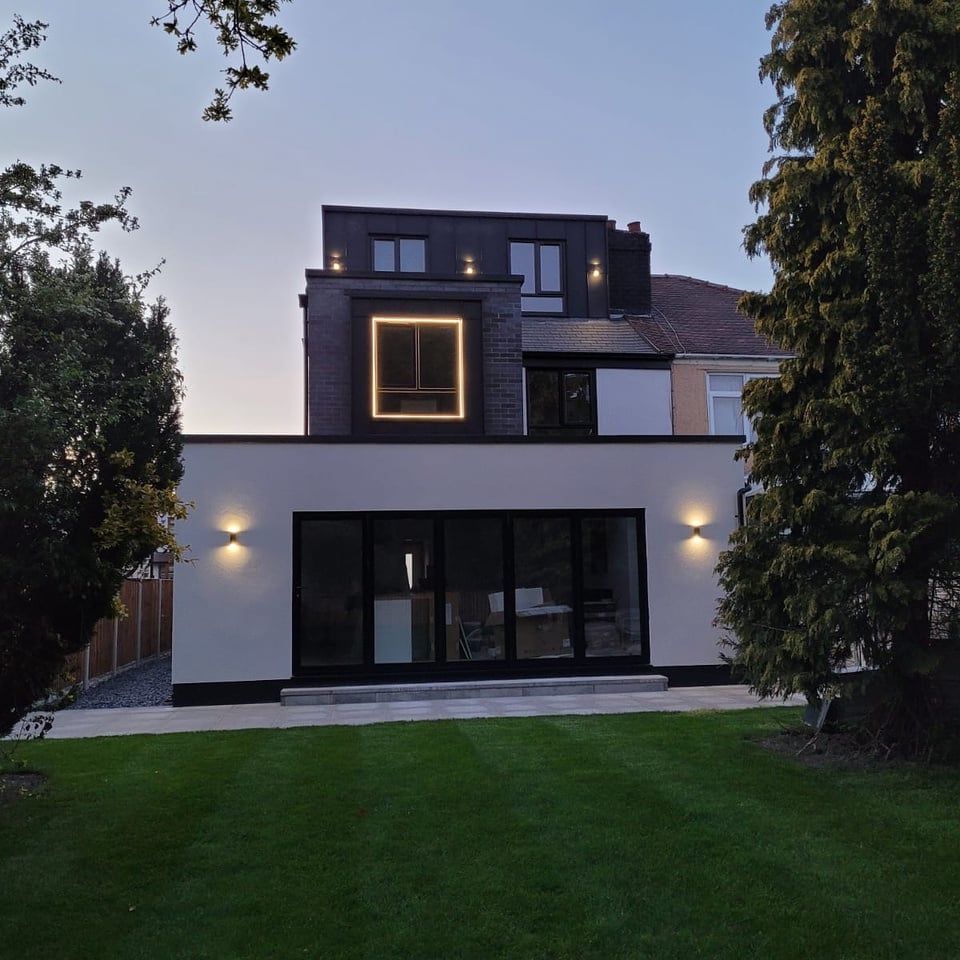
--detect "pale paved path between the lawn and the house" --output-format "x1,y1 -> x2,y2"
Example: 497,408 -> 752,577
16,686 -> 803,740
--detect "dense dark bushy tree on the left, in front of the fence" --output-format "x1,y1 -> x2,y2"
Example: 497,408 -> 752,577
0,252 -> 183,735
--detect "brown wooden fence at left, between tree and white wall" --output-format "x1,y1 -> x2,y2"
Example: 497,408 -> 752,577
67,578 -> 173,687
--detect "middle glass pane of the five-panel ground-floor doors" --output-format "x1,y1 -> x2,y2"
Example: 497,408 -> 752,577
444,516 -> 505,662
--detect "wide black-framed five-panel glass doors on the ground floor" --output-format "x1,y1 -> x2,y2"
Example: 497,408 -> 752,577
293,510 -> 650,678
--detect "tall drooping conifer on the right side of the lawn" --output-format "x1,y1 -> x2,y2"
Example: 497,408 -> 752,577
719,0 -> 960,752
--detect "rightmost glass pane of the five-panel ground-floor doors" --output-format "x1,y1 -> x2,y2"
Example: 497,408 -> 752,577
580,517 -> 643,657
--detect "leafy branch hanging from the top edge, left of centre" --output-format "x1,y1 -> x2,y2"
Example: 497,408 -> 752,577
150,0 -> 296,121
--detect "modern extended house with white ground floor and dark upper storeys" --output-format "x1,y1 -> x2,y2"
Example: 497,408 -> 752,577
173,206 -> 756,703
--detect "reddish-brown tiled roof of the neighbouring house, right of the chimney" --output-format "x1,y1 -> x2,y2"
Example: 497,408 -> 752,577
628,274 -> 783,357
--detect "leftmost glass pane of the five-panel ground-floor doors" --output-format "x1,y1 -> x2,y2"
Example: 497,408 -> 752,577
298,520 -> 363,667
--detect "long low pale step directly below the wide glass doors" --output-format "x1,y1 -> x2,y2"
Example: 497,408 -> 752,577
280,674 -> 667,707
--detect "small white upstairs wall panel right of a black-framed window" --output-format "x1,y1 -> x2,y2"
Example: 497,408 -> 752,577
597,369 -> 673,437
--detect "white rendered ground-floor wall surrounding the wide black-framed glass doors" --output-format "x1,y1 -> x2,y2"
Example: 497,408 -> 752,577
173,439 -> 743,683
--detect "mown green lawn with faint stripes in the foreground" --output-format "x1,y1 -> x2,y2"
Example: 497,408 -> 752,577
0,709 -> 960,960
